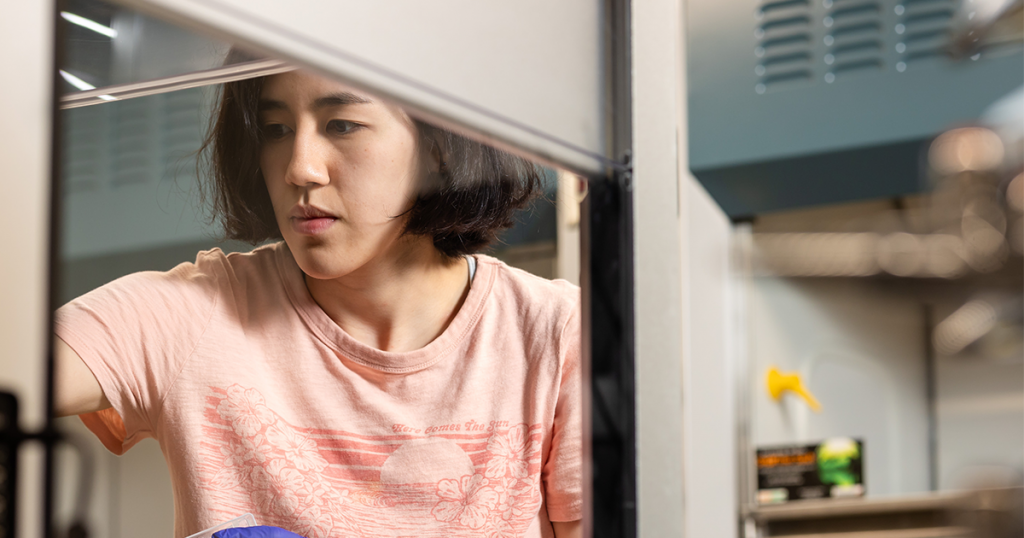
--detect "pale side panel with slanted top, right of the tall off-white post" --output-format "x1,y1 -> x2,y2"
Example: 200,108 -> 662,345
682,177 -> 738,538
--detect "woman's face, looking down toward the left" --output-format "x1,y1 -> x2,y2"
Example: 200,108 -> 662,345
259,72 -> 429,279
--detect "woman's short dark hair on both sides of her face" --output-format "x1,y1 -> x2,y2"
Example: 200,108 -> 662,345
194,57 -> 543,258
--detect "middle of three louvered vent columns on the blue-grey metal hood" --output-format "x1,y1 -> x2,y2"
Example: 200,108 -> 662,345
821,0 -> 886,84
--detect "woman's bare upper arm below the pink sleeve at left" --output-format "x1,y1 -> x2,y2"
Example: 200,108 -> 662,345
53,337 -> 111,416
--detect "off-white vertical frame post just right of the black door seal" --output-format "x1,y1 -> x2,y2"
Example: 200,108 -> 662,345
631,0 -> 686,538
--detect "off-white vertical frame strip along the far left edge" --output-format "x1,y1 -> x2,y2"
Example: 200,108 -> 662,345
0,2 -> 55,538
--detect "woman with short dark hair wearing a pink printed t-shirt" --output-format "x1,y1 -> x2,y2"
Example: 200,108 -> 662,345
56,72 -> 582,538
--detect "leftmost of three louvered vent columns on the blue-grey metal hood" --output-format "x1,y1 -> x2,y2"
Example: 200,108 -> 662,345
754,0 -> 815,93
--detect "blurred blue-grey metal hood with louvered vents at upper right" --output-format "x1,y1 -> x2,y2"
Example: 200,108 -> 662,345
687,0 -> 1024,218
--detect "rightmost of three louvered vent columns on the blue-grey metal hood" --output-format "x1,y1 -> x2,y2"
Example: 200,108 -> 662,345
893,0 -> 959,72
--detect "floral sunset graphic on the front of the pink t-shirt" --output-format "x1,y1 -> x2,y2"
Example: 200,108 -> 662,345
201,384 -> 543,538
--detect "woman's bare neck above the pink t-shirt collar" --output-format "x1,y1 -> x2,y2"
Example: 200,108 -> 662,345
305,238 -> 469,353
